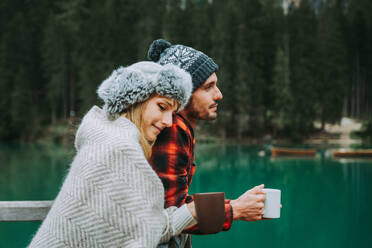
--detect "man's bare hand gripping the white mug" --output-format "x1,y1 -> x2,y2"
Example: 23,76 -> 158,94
230,184 -> 265,221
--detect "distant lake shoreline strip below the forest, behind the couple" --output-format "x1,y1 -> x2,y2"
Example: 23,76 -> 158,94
15,118 -> 368,147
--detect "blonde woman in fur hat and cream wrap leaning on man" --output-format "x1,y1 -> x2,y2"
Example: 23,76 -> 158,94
30,62 -> 195,248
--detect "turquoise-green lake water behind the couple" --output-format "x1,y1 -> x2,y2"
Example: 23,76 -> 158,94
0,145 -> 372,248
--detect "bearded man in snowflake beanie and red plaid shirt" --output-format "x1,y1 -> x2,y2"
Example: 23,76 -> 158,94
148,39 -> 265,247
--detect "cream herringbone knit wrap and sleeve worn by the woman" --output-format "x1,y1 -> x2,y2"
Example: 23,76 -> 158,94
29,106 -> 194,248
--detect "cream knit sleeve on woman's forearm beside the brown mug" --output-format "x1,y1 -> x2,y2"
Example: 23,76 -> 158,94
160,204 -> 196,243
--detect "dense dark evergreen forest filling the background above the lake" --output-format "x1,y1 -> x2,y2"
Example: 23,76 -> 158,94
0,0 -> 372,141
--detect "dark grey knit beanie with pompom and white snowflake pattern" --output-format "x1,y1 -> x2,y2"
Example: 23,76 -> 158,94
147,39 -> 218,91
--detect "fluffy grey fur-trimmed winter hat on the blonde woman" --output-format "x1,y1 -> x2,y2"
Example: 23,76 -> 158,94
97,61 -> 192,116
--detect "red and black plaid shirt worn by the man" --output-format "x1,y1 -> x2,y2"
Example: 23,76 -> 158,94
150,114 -> 233,234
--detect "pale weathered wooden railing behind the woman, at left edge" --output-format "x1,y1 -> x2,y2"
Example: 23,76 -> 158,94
0,201 -> 53,222
